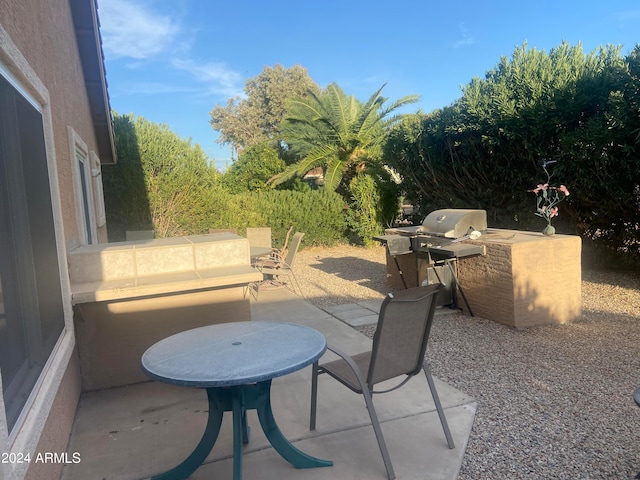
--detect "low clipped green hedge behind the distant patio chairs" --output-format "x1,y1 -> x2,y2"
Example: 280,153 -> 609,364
235,189 -> 346,246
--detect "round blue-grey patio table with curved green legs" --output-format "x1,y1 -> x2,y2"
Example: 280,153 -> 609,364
142,321 -> 333,480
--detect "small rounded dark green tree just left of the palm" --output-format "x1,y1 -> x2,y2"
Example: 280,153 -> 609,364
222,143 -> 286,193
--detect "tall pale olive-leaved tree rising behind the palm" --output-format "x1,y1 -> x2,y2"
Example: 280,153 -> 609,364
210,65 -> 320,152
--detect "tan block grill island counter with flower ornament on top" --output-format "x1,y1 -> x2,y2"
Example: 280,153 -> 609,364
458,228 -> 582,327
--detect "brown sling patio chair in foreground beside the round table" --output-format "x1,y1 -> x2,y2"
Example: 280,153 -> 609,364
309,283 -> 455,480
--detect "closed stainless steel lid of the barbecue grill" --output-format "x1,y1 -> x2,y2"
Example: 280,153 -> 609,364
420,208 -> 487,238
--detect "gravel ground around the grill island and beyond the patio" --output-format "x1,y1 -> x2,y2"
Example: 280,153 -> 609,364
295,246 -> 640,480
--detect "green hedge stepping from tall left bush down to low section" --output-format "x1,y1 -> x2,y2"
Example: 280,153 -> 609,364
103,114 -> 346,245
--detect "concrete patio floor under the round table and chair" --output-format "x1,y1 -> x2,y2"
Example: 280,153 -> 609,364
61,289 -> 476,480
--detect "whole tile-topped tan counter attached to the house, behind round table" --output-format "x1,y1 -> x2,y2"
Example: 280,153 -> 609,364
68,233 -> 262,390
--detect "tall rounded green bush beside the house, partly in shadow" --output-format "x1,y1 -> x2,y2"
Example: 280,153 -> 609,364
103,114 -> 239,241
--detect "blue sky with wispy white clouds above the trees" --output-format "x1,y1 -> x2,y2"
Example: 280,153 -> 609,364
98,0 -> 640,170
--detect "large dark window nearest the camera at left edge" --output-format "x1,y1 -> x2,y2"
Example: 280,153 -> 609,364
0,71 -> 64,431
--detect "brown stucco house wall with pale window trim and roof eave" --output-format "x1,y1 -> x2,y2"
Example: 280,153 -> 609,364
0,0 -> 115,480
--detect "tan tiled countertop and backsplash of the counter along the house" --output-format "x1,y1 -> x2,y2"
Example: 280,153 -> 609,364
68,233 -> 262,304
